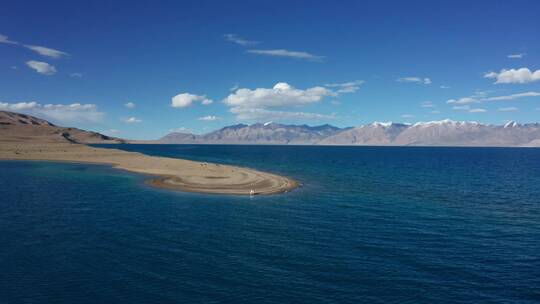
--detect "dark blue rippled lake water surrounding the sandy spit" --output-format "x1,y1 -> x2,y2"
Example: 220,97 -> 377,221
0,145 -> 540,303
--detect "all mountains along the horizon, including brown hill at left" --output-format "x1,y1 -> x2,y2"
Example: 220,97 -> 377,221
0,111 -> 540,147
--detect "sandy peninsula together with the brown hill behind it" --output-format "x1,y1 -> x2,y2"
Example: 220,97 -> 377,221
0,111 -> 298,195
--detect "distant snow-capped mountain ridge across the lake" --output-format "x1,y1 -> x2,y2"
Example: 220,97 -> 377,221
154,119 -> 540,147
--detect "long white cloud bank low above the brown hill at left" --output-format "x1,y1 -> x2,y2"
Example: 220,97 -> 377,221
0,101 -> 104,123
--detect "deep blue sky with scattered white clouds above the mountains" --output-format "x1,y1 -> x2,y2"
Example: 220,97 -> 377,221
0,1 -> 540,139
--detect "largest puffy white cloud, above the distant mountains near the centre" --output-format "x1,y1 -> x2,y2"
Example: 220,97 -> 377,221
223,82 -> 337,120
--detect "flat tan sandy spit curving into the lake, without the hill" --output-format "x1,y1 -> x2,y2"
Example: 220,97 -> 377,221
0,142 -> 299,195
